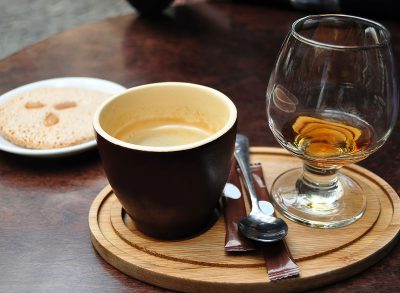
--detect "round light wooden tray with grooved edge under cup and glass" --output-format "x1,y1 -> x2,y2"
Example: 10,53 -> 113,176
89,147 -> 400,292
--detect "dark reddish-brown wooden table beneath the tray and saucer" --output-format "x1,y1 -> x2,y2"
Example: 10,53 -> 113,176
0,2 -> 400,292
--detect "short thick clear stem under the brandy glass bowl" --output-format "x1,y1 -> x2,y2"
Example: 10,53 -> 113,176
296,164 -> 343,205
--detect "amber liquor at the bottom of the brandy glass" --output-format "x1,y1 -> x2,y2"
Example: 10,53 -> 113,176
282,112 -> 374,167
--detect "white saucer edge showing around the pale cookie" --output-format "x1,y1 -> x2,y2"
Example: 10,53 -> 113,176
0,77 -> 126,157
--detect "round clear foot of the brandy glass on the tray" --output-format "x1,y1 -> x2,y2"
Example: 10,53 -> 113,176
271,168 -> 367,228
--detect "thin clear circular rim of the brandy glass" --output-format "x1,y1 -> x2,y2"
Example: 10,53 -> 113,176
290,13 -> 391,50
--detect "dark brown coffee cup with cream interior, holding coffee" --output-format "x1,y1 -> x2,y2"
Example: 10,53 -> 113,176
93,82 -> 237,239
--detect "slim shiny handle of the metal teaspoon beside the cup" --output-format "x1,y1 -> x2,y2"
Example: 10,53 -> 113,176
235,134 -> 260,214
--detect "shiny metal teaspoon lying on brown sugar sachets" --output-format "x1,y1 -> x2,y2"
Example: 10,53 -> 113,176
235,134 -> 288,242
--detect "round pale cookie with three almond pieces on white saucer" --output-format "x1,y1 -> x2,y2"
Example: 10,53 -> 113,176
0,87 -> 111,149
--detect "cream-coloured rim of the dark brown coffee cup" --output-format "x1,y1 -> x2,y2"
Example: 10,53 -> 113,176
93,82 -> 237,152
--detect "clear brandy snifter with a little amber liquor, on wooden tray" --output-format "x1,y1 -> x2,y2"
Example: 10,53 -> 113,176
266,14 -> 398,228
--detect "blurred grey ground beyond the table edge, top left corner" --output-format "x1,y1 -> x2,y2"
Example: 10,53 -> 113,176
0,0 -> 133,59
